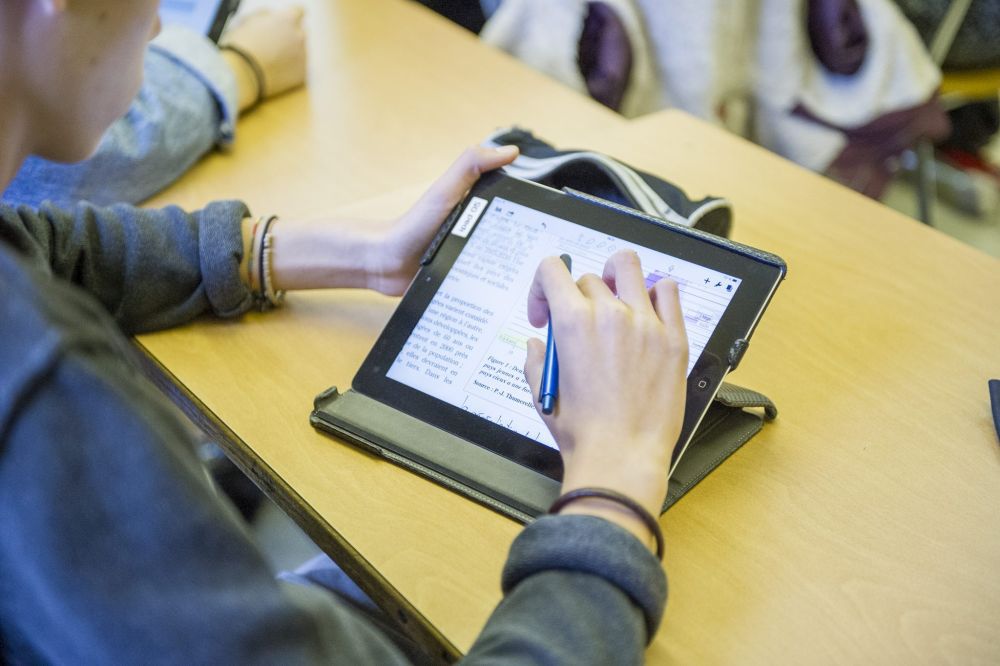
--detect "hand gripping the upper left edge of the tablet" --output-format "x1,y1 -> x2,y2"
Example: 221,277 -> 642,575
368,146 -> 517,296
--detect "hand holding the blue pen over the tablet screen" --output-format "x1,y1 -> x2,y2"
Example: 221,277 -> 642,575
524,251 -> 688,542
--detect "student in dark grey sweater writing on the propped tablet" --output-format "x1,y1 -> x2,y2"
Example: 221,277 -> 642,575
0,0 -> 687,664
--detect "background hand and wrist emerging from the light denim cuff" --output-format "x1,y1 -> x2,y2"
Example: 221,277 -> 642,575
220,7 -> 306,109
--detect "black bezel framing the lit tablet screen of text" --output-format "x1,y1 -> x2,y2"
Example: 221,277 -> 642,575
352,171 -> 785,481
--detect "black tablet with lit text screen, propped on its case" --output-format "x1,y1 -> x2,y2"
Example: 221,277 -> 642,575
324,172 -> 785,492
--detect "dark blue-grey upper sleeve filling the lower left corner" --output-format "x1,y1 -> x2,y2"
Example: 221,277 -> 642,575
0,330 -> 404,665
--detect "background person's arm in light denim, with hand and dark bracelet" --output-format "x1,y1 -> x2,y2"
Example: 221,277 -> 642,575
3,7 -> 306,207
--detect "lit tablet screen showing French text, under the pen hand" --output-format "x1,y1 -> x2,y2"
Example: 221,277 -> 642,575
386,197 -> 742,449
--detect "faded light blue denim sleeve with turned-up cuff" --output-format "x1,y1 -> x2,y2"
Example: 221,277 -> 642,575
3,28 -> 238,207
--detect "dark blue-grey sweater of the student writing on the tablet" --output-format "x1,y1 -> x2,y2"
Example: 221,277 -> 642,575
0,202 -> 666,665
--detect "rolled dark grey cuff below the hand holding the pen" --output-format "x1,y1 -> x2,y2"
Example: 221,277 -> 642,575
501,515 -> 667,644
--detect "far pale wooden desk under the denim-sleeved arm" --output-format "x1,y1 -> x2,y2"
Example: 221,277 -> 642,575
146,0 -> 626,217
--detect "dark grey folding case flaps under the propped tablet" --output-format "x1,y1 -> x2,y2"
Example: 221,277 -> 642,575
309,382 -> 778,523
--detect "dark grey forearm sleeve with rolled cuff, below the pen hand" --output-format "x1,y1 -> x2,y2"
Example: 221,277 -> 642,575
465,516 -> 667,664
